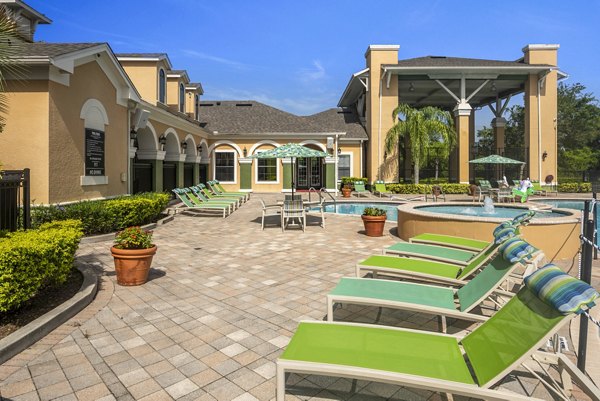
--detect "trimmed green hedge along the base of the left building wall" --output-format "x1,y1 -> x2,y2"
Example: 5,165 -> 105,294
31,192 -> 170,235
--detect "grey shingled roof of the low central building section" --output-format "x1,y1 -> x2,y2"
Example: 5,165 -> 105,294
200,100 -> 345,135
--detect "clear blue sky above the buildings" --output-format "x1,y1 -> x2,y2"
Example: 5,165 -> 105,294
26,0 -> 600,126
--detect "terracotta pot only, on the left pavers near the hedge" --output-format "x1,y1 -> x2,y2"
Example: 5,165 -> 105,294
110,245 -> 157,286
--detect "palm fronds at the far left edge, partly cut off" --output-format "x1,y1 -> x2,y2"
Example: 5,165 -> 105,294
0,6 -> 23,132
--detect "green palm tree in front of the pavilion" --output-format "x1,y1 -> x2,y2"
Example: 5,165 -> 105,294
385,104 -> 456,184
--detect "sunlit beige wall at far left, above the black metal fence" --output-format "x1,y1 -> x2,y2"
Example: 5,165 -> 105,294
0,80 -> 49,203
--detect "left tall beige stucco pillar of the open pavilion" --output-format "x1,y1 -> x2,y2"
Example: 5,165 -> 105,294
366,49 -> 398,181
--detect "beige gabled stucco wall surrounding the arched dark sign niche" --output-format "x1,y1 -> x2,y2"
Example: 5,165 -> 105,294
48,62 -> 129,203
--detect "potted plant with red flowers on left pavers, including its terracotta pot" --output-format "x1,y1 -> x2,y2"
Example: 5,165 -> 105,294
110,227 -> 157,286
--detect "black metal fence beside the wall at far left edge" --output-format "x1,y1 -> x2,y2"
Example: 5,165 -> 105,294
0,168 -> 31,231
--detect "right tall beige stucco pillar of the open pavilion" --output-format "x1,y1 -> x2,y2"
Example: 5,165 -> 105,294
524,49 -> 558,182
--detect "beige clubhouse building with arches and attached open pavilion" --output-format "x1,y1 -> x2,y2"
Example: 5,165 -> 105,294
0,0 -> 563,204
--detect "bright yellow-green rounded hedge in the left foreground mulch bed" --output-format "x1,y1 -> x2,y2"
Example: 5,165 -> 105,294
0,220 -> 83,312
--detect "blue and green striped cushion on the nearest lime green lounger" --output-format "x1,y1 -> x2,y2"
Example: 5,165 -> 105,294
525,263 -> 600,315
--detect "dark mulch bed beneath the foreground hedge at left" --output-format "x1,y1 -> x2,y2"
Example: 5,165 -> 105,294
0,269 -> 83,339
